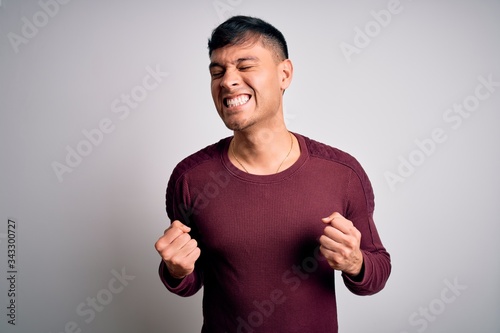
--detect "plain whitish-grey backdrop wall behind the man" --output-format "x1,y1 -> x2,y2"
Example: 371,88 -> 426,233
0,0 -> 500,333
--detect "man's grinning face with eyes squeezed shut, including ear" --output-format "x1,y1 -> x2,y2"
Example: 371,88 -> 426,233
210,40 -> 292,131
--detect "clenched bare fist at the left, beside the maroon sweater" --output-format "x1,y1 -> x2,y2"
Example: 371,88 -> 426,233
155,220 -> 201,279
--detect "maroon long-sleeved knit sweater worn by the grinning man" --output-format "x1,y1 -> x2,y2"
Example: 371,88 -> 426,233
160,134 -> 391,333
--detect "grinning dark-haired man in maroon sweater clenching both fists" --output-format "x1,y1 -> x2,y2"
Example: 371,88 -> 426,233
155,16 -> 391,333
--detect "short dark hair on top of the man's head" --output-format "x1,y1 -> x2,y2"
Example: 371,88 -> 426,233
208,15 -> 288,60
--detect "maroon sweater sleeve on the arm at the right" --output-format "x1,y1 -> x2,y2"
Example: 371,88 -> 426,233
342,169 -> 391,296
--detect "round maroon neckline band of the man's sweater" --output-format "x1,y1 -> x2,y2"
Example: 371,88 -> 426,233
221,132 -> 309,183
